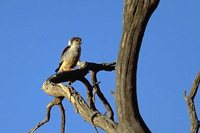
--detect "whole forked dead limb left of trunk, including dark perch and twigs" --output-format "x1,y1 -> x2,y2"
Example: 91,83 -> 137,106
30,62 -> 117,133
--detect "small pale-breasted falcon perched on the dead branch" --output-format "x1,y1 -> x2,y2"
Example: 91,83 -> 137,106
55,37 -> 82,73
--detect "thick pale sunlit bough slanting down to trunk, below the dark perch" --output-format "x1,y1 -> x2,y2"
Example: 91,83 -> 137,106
43,81 -> 117,133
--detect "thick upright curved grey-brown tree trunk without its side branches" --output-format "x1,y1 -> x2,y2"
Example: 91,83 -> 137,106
115,0 -> 159,133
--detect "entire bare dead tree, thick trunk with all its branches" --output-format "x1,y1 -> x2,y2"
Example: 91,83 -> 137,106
30,0 -> 199,133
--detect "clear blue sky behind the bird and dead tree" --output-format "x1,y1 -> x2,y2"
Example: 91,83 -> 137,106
0,0 -> 200,133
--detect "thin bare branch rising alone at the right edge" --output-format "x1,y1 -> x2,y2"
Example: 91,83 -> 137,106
184,73 -> 200,133
